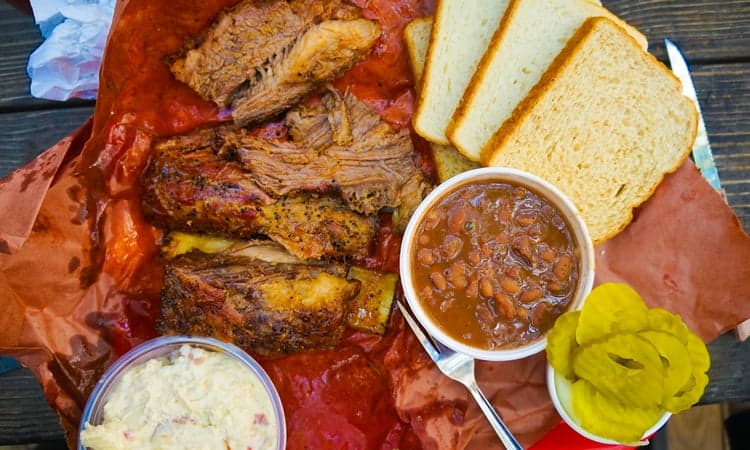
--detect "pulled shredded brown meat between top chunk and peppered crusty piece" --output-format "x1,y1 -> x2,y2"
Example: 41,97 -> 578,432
226,90 -> 430,225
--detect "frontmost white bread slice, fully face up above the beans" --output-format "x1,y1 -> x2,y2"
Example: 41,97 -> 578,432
483,17 -> 698,243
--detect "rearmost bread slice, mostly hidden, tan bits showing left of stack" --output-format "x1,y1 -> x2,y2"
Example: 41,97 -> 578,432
404,17 -> 479,182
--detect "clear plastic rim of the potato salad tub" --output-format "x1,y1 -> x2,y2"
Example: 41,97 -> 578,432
77,335 -> 287,450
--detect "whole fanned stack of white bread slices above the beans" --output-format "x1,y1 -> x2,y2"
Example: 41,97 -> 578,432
412,0 -> 698,243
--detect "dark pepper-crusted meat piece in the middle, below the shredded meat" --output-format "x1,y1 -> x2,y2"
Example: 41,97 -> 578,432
142,132 -> 376,259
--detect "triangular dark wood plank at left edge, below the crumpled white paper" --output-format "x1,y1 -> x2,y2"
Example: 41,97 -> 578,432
0,107 -> 93,178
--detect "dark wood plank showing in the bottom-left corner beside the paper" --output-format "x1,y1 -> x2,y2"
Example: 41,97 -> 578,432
0,369 -> 64,445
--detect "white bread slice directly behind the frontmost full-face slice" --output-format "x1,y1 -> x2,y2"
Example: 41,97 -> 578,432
447,0 -> 647,161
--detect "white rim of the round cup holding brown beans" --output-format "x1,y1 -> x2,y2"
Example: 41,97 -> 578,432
399,167 -> 595,361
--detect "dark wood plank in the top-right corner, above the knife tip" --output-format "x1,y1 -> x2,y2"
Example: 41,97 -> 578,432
602,0 -> 750,62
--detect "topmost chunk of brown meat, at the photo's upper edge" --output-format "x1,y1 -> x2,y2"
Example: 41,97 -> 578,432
171,0 -> 380,124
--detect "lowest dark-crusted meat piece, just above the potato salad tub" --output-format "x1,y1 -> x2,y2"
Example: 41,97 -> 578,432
157,252 -> 360,354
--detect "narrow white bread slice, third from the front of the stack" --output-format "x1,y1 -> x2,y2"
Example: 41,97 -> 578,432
412,0 -> 509,144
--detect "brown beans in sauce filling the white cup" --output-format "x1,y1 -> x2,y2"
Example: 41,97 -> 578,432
412,182 -> 579,350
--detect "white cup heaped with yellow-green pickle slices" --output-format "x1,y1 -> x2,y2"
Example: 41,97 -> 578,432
546,283 -> 710,445
